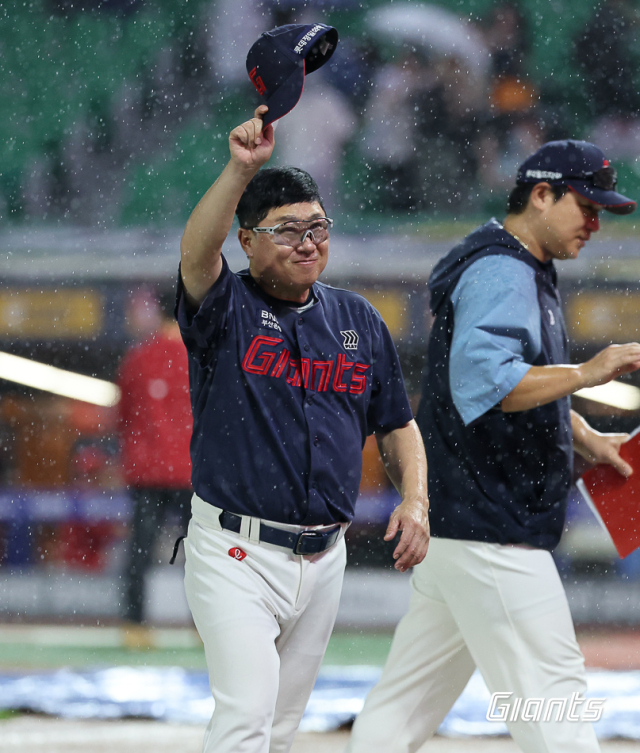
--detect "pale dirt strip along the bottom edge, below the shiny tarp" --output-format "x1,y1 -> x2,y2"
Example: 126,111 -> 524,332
0,715 -> 639,753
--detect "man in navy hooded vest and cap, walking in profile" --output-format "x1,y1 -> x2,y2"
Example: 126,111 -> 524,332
349,141 -> 640,753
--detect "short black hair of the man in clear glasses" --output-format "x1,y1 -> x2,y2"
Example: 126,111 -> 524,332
236,167 -> 325,228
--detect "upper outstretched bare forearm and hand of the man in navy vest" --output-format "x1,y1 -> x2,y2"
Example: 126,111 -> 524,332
501,343 -> 640,413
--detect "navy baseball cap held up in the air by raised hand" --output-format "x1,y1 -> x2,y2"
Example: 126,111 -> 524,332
247,24 -> 338,125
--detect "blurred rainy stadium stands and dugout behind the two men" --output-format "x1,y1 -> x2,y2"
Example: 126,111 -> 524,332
0,0 -> 640,748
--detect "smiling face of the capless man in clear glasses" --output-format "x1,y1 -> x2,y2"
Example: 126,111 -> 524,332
238,202 -> 329,303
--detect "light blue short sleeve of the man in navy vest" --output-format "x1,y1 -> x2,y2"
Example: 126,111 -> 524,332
449,255 -> 541,424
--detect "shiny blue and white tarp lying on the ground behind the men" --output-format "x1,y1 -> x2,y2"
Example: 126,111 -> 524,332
0,667 -> 640,740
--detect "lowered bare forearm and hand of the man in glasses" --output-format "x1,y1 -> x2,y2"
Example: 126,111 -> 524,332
376,421 -> 429,573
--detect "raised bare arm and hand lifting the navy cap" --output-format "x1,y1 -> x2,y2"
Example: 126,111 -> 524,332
180,105 -> 274,306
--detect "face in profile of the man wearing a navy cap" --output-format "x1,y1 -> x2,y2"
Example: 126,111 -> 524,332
538,189 -> 602,261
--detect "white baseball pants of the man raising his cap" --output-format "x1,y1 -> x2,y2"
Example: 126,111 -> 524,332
185,497 -> 346,753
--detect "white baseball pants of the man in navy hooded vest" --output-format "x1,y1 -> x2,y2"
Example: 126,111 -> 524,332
347,538 -> 600,753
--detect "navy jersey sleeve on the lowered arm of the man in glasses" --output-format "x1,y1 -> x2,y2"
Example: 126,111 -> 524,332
367,309 -> 413,434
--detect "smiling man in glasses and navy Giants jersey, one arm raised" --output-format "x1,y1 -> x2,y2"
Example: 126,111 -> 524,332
177,105 -> 429,753
